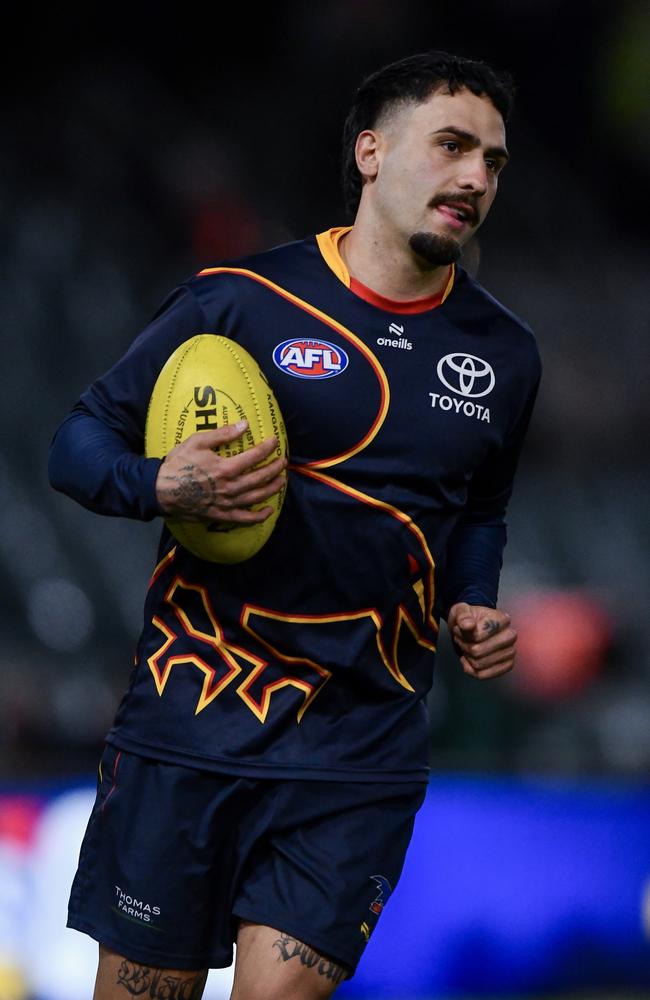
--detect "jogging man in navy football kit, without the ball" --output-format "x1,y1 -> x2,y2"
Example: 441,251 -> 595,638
50,52 -> 540,1000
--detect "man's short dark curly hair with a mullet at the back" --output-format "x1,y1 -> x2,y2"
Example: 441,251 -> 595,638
341,50 -> 515,218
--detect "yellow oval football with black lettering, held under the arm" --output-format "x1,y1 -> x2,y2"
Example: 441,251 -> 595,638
145,333 -> 288,563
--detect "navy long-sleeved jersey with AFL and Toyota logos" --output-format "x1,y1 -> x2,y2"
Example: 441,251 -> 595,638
50,230 -> 540,781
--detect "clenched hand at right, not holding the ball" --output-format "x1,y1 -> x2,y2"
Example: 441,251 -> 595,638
447,604 -> 517,681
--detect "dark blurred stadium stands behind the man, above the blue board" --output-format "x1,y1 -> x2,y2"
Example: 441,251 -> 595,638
0,0 -> 650,780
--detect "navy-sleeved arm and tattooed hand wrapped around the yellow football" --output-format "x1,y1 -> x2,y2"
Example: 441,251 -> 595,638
49,288 -> 286,524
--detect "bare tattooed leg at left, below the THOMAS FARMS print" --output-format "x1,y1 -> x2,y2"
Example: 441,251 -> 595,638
93,945 -> 208,1000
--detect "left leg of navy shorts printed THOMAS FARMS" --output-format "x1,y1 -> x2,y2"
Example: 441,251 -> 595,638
68,747 -> 252,968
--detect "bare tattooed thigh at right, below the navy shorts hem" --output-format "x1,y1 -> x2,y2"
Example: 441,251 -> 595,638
230,920 -> 347,1000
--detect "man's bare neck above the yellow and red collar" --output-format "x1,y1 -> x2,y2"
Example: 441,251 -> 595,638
338,218 -> 449,302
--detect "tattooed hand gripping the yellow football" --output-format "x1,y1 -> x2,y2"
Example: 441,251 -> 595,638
156,420 -> 287,524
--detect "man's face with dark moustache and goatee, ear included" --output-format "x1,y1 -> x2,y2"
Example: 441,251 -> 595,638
358,90 -> 507,266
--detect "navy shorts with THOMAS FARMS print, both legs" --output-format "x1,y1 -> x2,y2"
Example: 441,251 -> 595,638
68,746 -> 426,973
